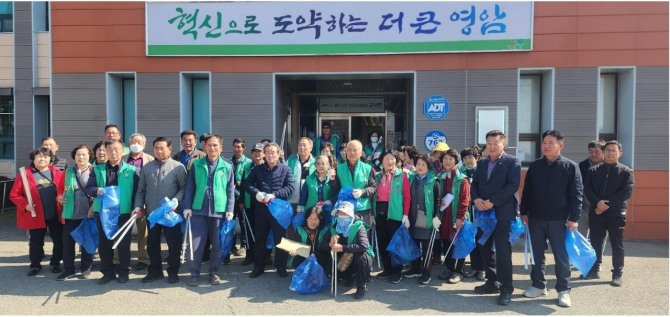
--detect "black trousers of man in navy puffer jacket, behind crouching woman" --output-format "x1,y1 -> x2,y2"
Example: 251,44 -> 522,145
254,204 -> 288,270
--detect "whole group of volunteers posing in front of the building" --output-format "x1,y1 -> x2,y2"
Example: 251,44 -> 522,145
10,123 -> 634,306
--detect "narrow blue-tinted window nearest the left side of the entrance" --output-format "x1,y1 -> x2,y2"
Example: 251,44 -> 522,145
180,73 -> 212,139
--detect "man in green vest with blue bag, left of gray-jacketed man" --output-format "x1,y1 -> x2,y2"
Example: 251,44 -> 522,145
86,139 -> 139,285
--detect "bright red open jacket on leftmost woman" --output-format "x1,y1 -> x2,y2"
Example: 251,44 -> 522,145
9,166 -> 65,229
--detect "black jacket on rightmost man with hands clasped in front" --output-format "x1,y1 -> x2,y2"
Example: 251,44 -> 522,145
584,163 -> 635,217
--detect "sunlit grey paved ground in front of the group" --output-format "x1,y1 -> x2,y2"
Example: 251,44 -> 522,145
0,211 -> 669,315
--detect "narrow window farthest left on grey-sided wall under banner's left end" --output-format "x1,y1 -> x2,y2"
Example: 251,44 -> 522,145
107,73 -> 137,142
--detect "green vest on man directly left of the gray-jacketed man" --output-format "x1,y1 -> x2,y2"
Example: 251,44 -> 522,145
93,161 -> 135,214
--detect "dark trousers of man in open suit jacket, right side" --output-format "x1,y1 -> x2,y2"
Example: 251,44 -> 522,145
477,220 -> 514,293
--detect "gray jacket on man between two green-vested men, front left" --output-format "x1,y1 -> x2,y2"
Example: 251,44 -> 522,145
134,158 -> 186,215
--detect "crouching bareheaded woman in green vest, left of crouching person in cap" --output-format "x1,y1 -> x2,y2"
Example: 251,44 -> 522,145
288,207 -> 332,271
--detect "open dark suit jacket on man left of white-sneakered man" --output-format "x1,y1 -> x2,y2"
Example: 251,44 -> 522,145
470,153 -> 521,221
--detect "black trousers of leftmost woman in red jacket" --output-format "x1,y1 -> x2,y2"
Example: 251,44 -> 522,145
28,217 -> 63,269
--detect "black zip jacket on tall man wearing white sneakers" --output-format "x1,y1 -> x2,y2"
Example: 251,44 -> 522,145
520,155 -> 584,222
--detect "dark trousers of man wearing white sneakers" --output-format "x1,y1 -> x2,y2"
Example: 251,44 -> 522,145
528,218 -> 570,292
